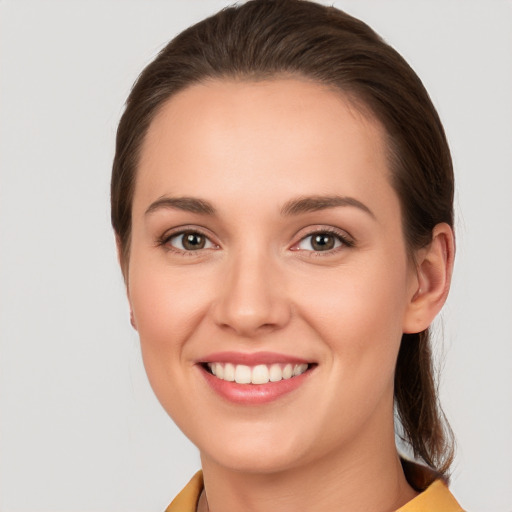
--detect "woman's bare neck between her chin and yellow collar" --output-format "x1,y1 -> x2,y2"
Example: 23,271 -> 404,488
198,422 -> 416,512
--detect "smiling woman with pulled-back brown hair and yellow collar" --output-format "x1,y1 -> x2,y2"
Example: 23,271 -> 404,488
112,0 -> 461,512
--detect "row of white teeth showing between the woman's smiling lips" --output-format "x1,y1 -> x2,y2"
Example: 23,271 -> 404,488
203,362 -> 313,384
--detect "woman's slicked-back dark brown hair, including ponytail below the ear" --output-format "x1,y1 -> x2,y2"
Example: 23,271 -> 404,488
111,0 -> 453,480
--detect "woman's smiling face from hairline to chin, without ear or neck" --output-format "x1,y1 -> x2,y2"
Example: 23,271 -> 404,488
128,79 -> 418,472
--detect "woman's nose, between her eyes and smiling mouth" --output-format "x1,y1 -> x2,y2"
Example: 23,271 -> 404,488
212,248 -> 292,338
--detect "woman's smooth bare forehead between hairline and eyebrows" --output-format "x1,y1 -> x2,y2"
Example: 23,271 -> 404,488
136,79 -> 396,216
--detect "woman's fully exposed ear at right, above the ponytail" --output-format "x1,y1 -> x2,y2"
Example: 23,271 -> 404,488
403,222 -> 455,333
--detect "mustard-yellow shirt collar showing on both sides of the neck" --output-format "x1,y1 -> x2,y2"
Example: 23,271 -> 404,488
165,471 -> 464,512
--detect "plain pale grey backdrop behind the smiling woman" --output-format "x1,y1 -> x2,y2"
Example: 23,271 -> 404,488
0,0 -> 512,512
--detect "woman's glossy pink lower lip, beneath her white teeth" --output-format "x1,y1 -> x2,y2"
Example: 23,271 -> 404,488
198,365 -> 312,405
